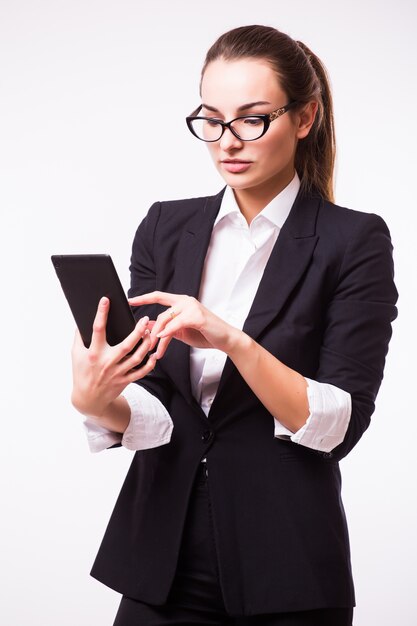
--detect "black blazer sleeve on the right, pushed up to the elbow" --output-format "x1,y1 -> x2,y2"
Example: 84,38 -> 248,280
313,214 -> 398,460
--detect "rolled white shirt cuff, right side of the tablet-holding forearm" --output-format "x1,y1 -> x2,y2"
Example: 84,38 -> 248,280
121,383 -> 174,450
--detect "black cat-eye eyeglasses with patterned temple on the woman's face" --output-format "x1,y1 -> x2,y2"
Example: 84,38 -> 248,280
185,100 -> 298,142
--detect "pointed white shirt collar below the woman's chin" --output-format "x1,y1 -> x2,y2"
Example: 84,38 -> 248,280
214,172 -> 301,228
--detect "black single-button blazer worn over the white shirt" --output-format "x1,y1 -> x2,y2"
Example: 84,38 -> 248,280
92,185 -> 397,615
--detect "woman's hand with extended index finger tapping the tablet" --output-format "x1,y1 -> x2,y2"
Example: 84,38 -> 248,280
129,291 -> 242,359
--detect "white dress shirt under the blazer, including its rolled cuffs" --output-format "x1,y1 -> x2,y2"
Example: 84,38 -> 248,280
84,174 -> 351,452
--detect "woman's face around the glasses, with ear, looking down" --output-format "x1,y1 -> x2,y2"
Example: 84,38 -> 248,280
199,58 -> 314,195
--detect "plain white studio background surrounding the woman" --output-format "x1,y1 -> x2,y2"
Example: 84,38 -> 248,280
0,0 -> 417,626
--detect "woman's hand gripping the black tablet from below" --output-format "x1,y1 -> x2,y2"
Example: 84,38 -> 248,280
71,298 -> 156,419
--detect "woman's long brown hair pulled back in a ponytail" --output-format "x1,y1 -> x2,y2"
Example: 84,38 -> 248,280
201,25 -> 336,202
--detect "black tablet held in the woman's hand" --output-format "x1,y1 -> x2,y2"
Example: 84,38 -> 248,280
51,254 -> 147,365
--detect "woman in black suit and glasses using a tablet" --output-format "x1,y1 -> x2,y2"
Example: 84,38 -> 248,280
72,26 -> 397,626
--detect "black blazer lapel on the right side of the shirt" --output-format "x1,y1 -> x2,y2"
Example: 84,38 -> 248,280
218,193 -> 321,393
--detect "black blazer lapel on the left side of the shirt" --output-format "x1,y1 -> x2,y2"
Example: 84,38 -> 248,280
165,188 -> 225,400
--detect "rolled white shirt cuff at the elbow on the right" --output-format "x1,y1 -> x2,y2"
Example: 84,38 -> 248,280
274,378 -> 352,452
